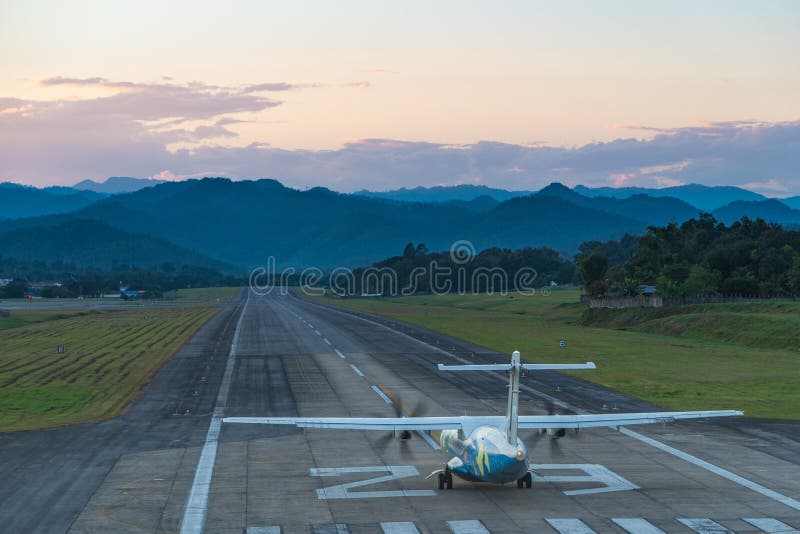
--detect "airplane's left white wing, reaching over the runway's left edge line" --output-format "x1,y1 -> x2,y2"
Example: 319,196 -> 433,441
222,417 -> 468,431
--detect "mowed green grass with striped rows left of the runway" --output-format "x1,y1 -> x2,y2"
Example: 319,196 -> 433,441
0,306 -> 219,431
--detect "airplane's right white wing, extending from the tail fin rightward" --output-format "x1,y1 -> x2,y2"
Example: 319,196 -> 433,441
519,410 -> 744,429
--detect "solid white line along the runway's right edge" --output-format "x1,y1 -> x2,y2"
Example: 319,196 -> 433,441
292,295 -> 800,510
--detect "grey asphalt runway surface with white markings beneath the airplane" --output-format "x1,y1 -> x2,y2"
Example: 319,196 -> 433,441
0,294 -> 800,534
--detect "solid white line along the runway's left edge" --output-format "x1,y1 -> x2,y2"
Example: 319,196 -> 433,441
180,291 -> 250,534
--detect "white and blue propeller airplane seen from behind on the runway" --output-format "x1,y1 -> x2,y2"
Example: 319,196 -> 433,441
223,351 -> 743,489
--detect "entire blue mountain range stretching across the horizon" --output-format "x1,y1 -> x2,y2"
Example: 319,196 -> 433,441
0,178 -> 800,270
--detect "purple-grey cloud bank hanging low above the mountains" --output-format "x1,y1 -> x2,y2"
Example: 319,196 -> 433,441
0,77 -> 800,195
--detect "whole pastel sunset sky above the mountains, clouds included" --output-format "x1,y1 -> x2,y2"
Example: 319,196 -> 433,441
0,0 -> 800,196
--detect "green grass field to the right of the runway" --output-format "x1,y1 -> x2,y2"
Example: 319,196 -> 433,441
308,289 -> 800,419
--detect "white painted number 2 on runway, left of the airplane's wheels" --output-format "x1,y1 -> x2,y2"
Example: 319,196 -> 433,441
308,465 -> 436,499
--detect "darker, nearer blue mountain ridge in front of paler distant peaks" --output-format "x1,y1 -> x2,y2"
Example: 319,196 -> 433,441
0,178 -> 795,268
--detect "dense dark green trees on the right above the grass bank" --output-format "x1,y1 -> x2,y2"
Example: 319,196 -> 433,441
576,214 -> 800,297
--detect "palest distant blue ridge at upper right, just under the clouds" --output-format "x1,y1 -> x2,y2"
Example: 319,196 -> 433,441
575,184 -> 766,212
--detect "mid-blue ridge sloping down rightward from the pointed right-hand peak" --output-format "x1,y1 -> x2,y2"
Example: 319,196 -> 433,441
536,183 -> 700,226
